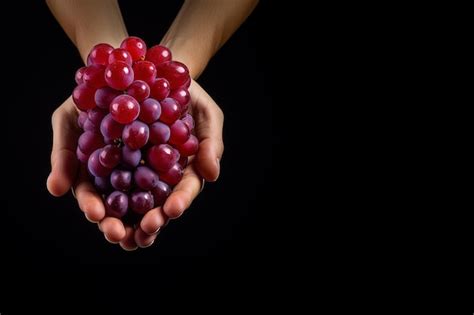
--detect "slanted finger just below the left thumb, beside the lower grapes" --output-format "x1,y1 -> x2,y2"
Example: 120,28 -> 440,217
74,166 -> 105,222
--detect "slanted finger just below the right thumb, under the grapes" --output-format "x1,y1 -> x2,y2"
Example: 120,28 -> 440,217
163,165 -> 202,219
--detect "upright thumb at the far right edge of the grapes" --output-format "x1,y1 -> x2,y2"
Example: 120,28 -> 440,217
195,91 -> 224,182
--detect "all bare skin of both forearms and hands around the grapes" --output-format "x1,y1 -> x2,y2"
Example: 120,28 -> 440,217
47,0 -> 257,250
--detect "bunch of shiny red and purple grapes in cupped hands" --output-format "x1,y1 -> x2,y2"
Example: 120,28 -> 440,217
72,37 -> 199,223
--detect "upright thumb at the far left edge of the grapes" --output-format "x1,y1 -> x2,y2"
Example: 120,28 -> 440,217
46,108 -> 79,196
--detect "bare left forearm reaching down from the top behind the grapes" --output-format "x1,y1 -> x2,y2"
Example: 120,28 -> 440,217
46,0 -> 128,62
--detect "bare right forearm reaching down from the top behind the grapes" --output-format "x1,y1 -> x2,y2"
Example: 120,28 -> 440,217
162,0 -> 258,78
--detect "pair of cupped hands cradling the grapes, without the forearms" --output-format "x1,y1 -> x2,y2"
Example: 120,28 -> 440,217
47,81 -> 224,250
